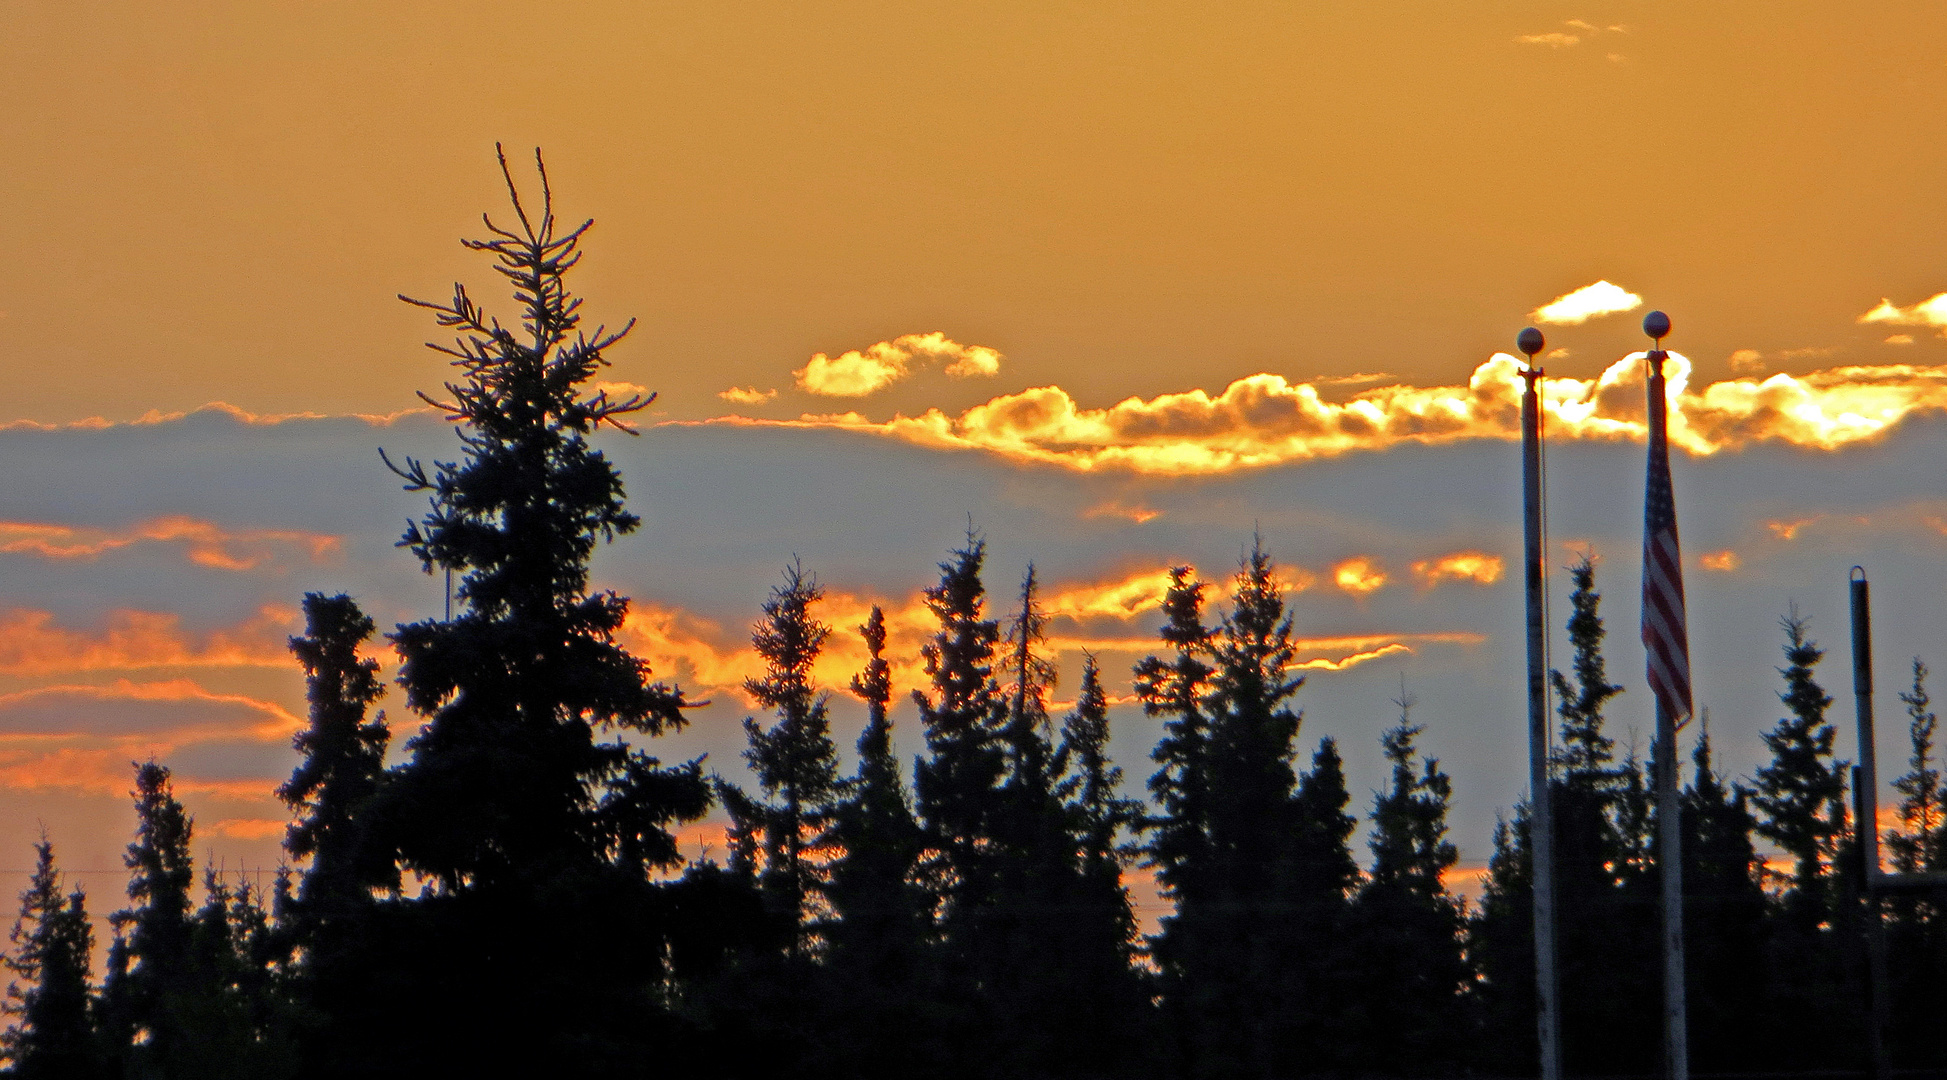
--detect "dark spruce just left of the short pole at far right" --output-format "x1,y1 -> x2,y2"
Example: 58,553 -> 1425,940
1750,605 -> 1863,1068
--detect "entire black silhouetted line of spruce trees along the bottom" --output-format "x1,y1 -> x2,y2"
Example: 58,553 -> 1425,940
4,154 -> 1947,1080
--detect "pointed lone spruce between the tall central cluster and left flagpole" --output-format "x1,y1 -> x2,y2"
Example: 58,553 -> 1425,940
1345,685 -> 1472,1076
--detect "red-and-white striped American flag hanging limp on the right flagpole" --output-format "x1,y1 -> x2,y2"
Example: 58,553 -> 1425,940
1643,350 -> 1692,722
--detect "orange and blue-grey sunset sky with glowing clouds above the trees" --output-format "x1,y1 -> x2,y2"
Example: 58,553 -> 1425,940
0,0 -> 1947,911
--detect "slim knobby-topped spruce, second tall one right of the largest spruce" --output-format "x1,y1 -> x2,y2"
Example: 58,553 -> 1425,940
822,605 -> 946,1076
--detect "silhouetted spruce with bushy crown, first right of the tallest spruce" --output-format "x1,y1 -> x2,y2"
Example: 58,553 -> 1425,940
744,562 -> 839,941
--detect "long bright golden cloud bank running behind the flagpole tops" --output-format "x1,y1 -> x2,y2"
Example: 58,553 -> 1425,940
705,352 -> 1947,477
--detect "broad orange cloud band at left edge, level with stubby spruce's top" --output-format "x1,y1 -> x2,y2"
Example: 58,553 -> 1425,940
0,607 -> 298,675
